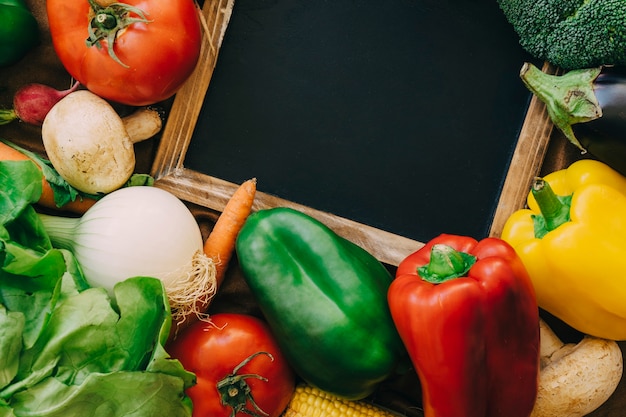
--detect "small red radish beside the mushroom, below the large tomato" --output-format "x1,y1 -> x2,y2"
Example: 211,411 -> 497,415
0,81 -> 80,126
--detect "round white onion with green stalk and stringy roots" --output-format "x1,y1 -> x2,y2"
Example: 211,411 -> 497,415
40,186 -> 216,322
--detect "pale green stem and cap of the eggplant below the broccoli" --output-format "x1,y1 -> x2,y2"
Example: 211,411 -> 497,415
520,62 -> 602,151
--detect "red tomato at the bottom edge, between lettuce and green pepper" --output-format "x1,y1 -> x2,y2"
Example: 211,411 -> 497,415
167,313 -> 295,417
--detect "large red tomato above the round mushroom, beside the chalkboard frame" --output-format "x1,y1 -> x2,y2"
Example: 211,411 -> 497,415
46,0 -> 202,106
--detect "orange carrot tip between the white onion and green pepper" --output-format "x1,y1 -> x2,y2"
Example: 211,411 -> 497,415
204,178 -> 256,286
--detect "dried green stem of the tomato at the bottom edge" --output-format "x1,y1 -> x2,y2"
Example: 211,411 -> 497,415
216,352 -> 274,417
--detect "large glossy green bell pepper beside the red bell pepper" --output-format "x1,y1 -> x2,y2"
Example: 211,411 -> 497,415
237,207 -> 408,400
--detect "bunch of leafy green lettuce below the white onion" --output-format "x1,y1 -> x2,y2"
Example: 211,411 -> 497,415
0,161 -> 194,417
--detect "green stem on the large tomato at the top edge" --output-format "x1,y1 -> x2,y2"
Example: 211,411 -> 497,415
85,0 -> 152,68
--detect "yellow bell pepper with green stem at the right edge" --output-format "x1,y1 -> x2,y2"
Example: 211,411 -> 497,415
501,160 -> 626,340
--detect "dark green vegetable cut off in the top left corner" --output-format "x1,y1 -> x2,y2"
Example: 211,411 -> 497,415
0,0 -> 40,67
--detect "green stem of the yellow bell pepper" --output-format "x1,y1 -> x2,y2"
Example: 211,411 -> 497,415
531,177 -> 571,238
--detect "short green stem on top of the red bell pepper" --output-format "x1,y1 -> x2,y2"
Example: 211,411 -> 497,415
417,244 -> 476,284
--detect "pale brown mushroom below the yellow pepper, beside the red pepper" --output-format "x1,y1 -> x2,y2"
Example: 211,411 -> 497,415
531,321 -> 623,417
